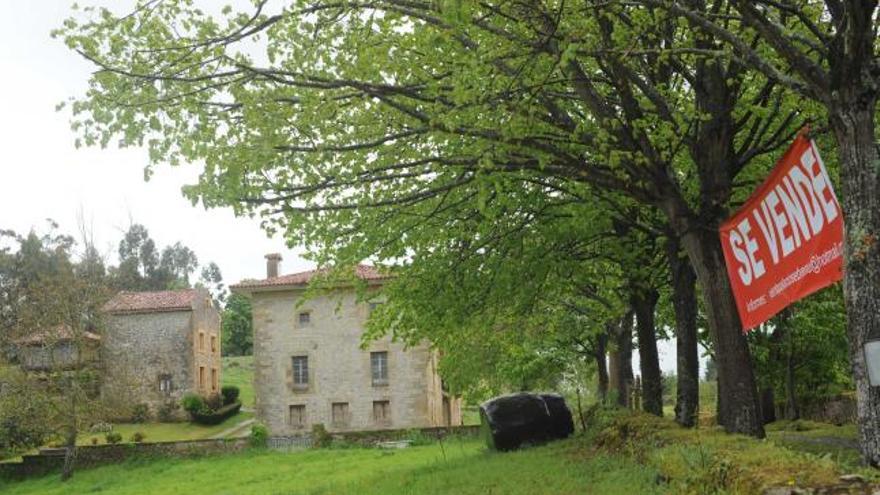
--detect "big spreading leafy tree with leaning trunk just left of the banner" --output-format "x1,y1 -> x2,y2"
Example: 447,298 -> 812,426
57,0 -> 812,436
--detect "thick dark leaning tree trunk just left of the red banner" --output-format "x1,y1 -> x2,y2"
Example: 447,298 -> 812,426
672,221 -> 764,438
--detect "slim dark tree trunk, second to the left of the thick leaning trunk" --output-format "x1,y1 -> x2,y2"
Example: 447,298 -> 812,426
630,288 -> 663,416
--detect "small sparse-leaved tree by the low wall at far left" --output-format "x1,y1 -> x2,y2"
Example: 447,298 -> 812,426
0,224 -> 109,479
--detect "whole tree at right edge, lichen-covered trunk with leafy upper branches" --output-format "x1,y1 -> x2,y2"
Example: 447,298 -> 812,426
643,0 -> 880,466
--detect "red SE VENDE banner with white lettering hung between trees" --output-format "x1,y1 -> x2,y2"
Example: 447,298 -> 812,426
721,135 -> 843,331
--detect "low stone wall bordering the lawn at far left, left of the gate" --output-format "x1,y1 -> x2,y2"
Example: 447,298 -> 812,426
0,438 -> 248,479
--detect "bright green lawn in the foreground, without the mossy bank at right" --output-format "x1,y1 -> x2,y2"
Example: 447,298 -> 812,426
0,439 -> 662,495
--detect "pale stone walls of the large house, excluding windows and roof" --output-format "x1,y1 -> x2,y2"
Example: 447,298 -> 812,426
252,289 -> 460,435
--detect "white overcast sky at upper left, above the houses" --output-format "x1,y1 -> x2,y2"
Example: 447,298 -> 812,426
0,0 -> 675,371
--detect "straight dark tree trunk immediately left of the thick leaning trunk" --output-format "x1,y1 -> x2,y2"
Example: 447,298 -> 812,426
666,235 -> 700,427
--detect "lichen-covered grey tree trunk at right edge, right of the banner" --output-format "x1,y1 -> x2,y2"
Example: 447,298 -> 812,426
830,102 -> 880,467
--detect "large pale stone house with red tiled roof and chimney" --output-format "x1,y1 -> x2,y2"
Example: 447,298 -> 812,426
232,254 -> 461,435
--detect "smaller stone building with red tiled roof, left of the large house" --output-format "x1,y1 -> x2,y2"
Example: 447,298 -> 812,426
101,289 -> 221,418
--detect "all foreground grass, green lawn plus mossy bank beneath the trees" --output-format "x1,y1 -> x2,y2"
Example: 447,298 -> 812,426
0,409 -> 880,495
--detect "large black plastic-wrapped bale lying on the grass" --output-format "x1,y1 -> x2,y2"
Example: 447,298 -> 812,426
480,392 -> 574,450
